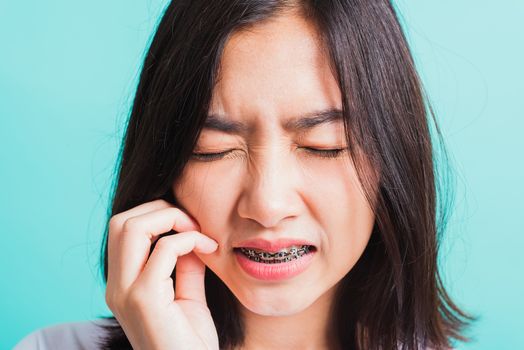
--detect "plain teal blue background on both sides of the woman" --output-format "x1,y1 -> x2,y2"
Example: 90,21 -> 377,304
0,0 -> 524,350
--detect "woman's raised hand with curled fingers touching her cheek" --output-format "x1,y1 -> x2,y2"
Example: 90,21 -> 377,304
106,200 -> 218,350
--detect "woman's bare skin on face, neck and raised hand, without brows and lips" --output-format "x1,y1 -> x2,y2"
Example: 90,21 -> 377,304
106,10 -> 374,350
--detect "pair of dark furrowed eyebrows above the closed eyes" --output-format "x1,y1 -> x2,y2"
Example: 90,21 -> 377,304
204,108 -> 343,135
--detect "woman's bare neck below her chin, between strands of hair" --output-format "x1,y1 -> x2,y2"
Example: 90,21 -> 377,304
234,287 -> 338,350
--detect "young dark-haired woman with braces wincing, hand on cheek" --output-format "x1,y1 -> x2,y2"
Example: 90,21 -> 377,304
15,0 -> 473,349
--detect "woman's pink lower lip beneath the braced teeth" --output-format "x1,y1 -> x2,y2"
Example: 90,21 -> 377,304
235,252 -> 315,281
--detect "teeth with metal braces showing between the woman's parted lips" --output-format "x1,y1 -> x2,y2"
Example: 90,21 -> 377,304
234,245 -> 316,264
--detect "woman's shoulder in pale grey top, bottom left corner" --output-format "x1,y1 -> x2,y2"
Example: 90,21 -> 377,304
13,319 -> 113,350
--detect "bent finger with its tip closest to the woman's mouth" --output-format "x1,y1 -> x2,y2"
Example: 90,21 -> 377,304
139,231 -> 218,284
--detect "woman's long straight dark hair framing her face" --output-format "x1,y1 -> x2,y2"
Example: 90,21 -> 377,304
96,0 -> 475,349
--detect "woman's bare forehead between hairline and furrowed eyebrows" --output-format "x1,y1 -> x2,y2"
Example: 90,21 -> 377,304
208,14 -> 341,134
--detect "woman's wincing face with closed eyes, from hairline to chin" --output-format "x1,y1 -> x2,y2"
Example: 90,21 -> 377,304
173,15 -> 374,316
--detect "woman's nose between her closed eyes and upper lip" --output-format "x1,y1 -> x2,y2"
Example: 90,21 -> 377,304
238,144 -> 302,228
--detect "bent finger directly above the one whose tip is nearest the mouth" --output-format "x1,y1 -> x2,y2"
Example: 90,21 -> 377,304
109,207 -> 203,289
